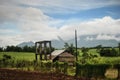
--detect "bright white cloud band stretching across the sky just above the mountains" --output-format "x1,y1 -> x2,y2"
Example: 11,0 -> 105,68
0,16 -> 120,44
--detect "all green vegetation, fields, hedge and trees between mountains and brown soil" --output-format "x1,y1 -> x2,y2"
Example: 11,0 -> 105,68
0,43 -> 120,79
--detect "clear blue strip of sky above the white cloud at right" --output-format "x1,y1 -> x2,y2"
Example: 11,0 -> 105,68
48,5 -> 120,19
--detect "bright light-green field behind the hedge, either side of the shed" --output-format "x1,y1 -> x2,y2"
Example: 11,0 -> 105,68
0,49 -> 120,64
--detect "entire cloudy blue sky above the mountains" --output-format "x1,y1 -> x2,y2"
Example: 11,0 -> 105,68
0,0 -> 120,47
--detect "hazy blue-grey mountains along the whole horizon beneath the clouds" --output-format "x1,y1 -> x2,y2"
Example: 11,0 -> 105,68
17,35 -> 119,49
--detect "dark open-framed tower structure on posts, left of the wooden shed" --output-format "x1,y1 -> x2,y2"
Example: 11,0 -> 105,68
35,41 -> 52,60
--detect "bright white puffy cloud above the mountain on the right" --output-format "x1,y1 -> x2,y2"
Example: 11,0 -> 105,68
59,16 -> 120,39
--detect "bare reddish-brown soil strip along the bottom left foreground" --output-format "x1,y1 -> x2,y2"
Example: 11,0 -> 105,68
0,68 -> 83,80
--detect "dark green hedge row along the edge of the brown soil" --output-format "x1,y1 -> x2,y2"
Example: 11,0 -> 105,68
0,53 -> 120,79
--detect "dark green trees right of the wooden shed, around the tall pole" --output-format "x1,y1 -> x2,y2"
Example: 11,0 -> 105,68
64,43 -> 120,57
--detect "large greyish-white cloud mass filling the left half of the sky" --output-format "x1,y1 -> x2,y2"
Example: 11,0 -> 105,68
0,2 -> 57,46
